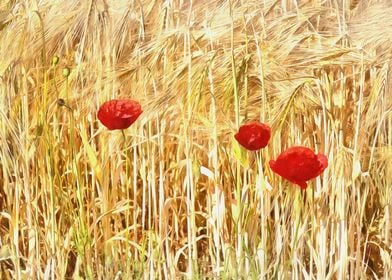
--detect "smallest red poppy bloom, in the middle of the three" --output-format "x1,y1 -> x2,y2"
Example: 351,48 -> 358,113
234,122 -> 271,151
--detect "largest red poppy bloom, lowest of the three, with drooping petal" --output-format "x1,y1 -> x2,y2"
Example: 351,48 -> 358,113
269,146 -> 328,190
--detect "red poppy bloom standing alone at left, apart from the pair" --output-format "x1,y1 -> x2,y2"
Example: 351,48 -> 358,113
98,99 -> 143,130
